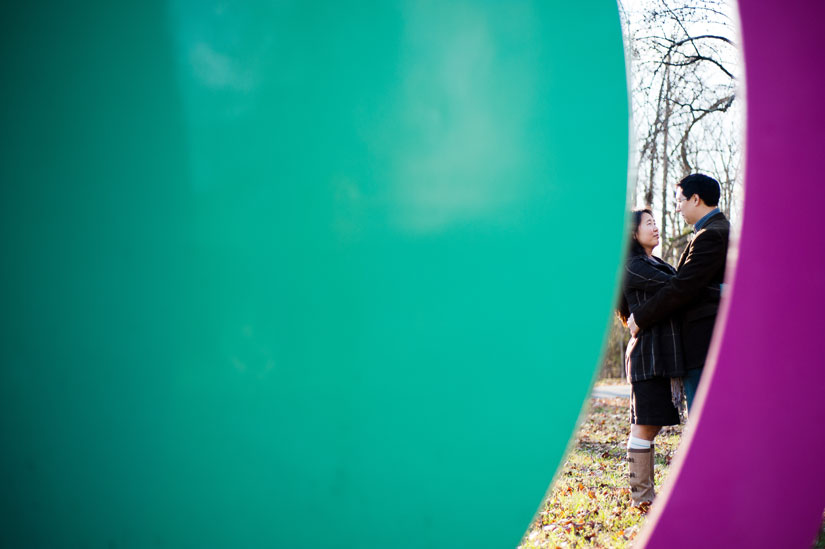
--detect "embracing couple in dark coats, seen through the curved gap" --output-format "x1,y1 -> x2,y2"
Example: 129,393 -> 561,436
619,174 -> 730,505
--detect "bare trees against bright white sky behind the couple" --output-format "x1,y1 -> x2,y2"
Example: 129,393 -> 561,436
602,0 -> 741,376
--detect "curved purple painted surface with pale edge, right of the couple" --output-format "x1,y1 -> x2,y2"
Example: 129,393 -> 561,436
639,0 -> 825,548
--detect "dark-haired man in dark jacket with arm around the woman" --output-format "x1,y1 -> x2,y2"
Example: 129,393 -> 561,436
627,174 -> 730,410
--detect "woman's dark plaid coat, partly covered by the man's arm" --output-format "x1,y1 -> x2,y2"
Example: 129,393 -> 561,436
622,254 -> 686,382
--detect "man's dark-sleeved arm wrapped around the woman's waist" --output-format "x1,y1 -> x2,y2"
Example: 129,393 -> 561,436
633,231 -> 727,329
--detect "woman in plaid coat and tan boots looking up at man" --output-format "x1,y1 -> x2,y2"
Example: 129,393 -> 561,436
618,209 -> 686,505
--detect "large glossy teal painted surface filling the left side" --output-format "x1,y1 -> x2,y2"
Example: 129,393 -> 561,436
0,1 -> 628,547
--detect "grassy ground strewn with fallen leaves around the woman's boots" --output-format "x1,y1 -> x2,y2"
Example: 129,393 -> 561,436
519,398 -> 682,549
